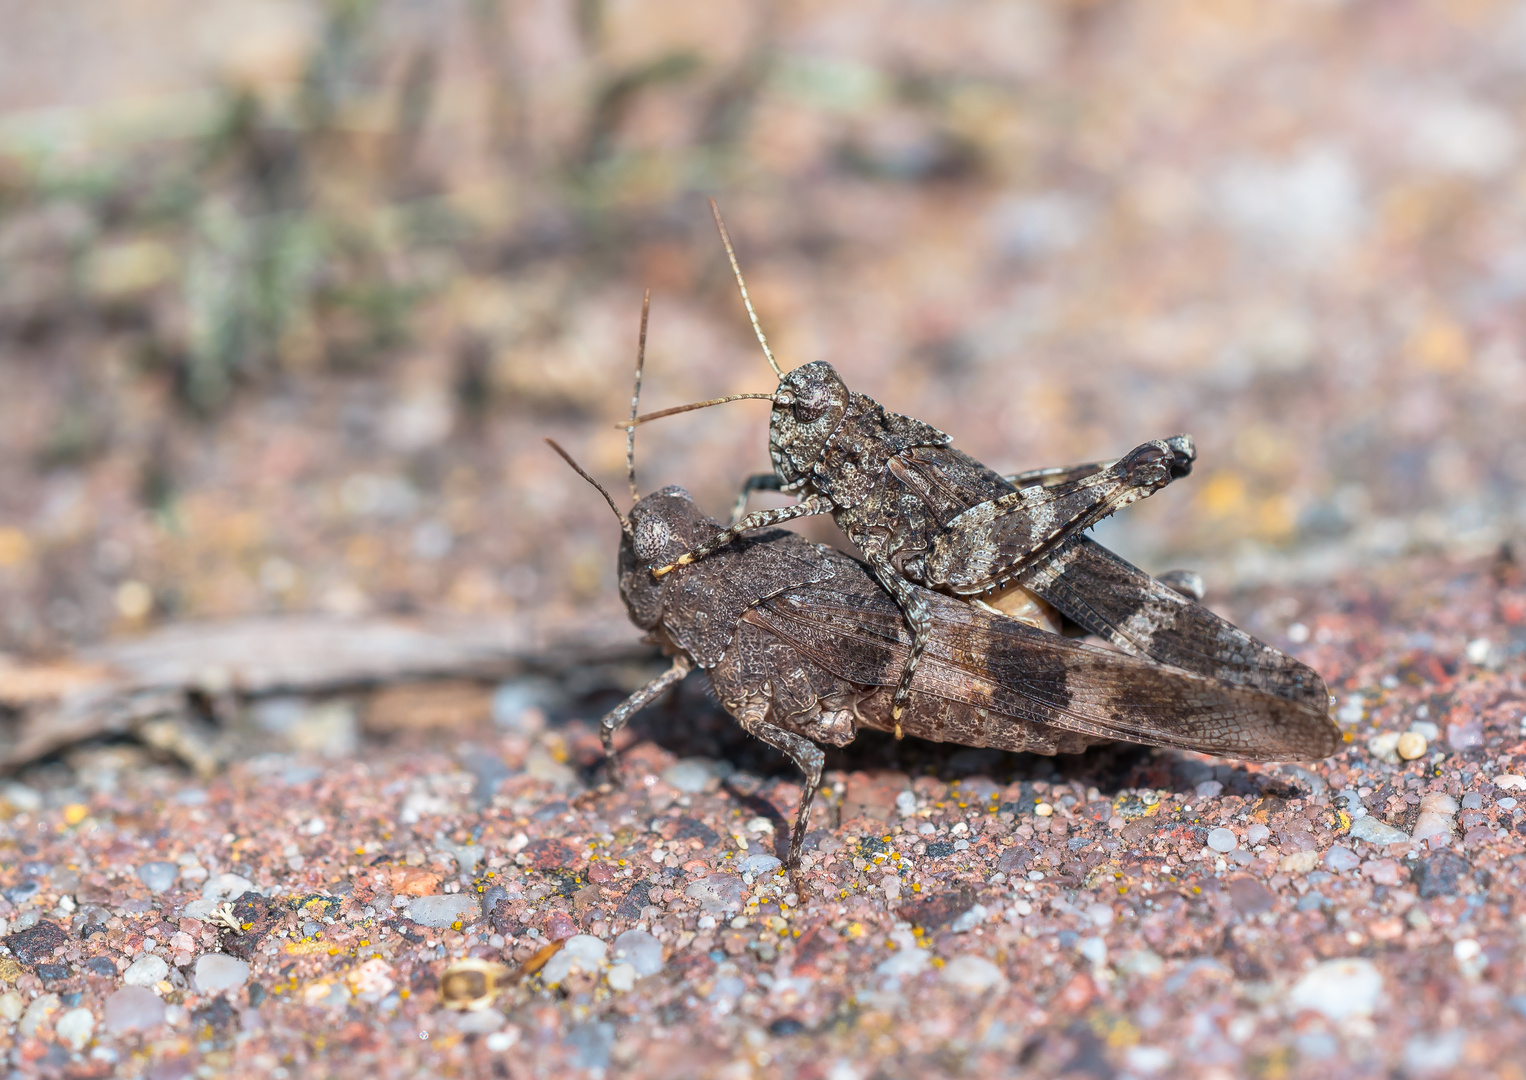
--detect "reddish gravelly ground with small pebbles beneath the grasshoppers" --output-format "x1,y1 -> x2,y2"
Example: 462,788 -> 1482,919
0,558 -> 1526,1080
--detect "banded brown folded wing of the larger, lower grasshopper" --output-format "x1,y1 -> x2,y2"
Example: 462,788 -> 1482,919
746,560 -> 1340,761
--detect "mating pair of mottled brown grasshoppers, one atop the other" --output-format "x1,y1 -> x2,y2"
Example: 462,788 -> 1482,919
559,214 -> 1340,866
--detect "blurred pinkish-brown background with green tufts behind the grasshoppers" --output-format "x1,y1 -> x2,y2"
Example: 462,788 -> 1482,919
0,0 -> 1526,656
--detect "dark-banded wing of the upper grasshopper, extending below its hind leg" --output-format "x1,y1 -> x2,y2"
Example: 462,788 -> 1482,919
1018,537 -> 1329,715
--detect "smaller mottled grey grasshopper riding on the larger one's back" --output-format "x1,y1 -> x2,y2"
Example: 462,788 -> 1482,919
624,200 -> 1328,737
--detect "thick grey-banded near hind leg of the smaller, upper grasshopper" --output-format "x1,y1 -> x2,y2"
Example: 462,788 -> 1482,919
926,441 -> 1190,595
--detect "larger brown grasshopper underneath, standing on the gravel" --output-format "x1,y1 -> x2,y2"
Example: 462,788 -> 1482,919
551,295 -> 1340,869
